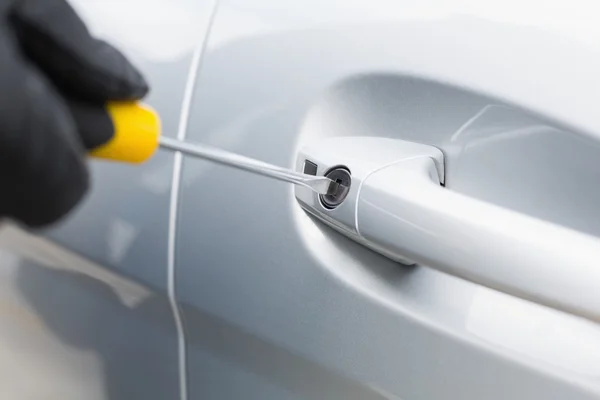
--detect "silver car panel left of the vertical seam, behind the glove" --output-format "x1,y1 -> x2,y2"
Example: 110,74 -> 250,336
0,0 -> 212,400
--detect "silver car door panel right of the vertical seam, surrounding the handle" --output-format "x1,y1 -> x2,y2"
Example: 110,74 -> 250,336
175,0 -> 600,400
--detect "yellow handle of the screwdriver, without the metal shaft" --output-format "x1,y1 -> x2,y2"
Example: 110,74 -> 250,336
89,102 -> 161,163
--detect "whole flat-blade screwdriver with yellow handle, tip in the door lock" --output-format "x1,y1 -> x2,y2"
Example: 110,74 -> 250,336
90,102 -> 348,196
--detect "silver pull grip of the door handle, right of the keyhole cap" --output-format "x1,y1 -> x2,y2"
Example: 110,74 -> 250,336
356,153 -> 600,322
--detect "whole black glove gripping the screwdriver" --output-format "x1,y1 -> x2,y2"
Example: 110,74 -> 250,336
0,0 -> 148,227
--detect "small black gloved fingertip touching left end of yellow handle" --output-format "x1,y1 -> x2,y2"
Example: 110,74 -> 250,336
67,99 -> 115,150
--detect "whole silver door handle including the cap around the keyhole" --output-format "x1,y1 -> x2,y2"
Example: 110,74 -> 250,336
296,137 -> 600,321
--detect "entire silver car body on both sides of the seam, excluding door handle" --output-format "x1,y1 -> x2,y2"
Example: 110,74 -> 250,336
0,0 -> 600,400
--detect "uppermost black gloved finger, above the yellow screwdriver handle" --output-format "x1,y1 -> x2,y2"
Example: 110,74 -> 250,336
10,0 -> 148,102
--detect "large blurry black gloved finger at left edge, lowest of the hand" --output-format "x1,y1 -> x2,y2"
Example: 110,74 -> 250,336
0,26 -> 89,227
